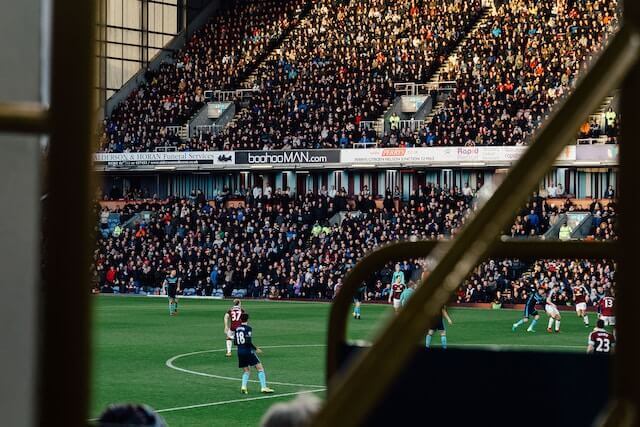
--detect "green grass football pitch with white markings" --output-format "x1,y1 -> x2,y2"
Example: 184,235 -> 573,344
90,297 -> 595,427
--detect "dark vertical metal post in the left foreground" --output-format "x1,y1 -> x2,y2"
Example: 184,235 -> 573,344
38,0 -> 96,426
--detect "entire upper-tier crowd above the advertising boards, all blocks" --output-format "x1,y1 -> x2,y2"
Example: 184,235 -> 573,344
101,0 -> 618,151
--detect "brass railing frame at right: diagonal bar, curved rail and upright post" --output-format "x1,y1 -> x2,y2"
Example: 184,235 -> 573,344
313,17 -> 640,426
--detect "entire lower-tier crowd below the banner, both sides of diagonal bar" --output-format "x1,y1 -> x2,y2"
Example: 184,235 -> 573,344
93,185 -> 616,303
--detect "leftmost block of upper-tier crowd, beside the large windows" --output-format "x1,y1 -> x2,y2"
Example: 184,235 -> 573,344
100,0 -> 307,152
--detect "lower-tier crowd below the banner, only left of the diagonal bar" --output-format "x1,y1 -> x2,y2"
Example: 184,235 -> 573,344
94,187 -> 471,298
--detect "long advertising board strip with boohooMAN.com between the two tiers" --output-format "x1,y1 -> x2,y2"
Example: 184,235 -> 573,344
94,144 -> 618,170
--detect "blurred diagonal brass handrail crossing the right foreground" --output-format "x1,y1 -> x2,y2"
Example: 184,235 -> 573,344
313,22 -> 640,426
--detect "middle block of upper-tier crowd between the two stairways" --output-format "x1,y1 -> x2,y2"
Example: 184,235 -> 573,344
208,0 -> 480,150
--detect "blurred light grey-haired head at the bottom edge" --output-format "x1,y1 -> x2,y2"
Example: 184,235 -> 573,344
260,394 -> 320,427
